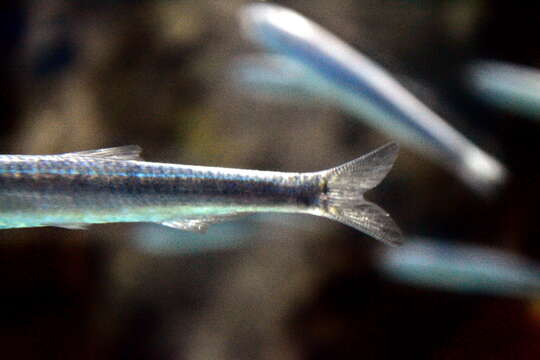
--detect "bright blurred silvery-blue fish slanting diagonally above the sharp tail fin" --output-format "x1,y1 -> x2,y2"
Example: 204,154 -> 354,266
239,3 -> 508,197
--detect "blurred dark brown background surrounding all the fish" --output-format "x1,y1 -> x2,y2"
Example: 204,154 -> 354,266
0,0 -> 540,359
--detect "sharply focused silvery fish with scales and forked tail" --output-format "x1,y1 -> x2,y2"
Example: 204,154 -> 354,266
0,143 -> 401,245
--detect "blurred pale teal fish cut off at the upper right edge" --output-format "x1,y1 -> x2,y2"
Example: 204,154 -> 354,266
466,61 -> 540,120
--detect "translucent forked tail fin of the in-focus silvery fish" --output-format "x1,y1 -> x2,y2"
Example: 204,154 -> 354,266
321,143 -> 401,245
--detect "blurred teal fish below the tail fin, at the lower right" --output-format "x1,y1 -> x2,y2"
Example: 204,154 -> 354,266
376,238 -> 540,298
